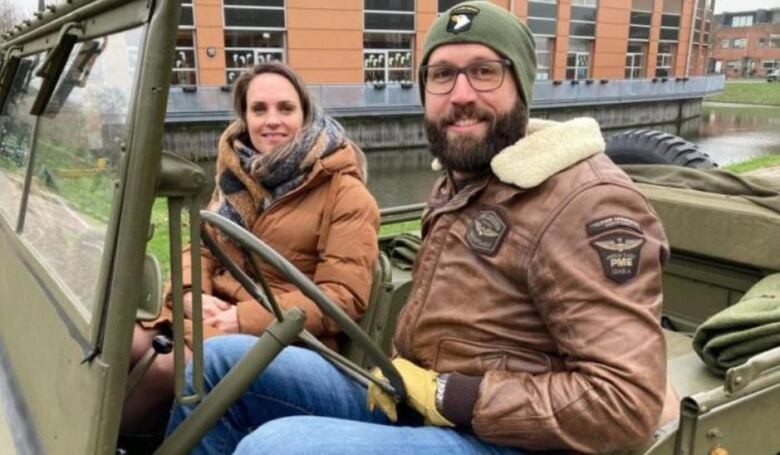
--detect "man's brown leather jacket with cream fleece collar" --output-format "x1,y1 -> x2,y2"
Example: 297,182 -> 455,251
395,119 -> 676,452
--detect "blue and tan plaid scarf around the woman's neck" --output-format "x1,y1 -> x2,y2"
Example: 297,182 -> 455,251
208,107 -> 345,230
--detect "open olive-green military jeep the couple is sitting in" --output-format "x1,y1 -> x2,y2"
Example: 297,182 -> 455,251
0,0 -> 780,455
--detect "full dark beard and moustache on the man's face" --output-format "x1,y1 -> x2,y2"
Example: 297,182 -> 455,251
423,98 -> 528,173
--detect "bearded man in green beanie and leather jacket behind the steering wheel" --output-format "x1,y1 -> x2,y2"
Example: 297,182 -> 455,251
172,2 -> 676,454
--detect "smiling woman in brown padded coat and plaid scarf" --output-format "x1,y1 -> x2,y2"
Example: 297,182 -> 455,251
123,62 -> 379,432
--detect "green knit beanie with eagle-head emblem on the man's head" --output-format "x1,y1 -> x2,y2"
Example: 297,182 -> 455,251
420,1 -> 536,106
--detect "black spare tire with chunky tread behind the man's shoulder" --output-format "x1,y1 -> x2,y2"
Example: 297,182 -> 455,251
605,130 -> 718,169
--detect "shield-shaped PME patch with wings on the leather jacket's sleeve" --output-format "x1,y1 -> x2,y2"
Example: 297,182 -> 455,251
590,233 -> 645,283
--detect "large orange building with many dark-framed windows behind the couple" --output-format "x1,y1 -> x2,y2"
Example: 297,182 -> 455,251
173,0 -> 712,85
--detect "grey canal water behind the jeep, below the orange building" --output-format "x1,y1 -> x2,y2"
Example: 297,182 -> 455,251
367,103 -> 780,207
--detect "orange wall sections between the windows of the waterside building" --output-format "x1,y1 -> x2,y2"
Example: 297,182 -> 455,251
193,0 -> 707,85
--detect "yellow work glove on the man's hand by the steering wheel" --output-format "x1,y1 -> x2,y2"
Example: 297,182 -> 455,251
367,357 -> 455,427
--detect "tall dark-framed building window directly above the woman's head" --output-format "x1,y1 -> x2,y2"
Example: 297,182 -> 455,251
223,0 -> 286,84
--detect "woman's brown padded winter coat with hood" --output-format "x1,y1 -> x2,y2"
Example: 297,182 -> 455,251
144,141 -> 379,347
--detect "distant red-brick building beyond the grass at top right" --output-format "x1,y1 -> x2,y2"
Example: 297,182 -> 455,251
710,8 -> 780,78
